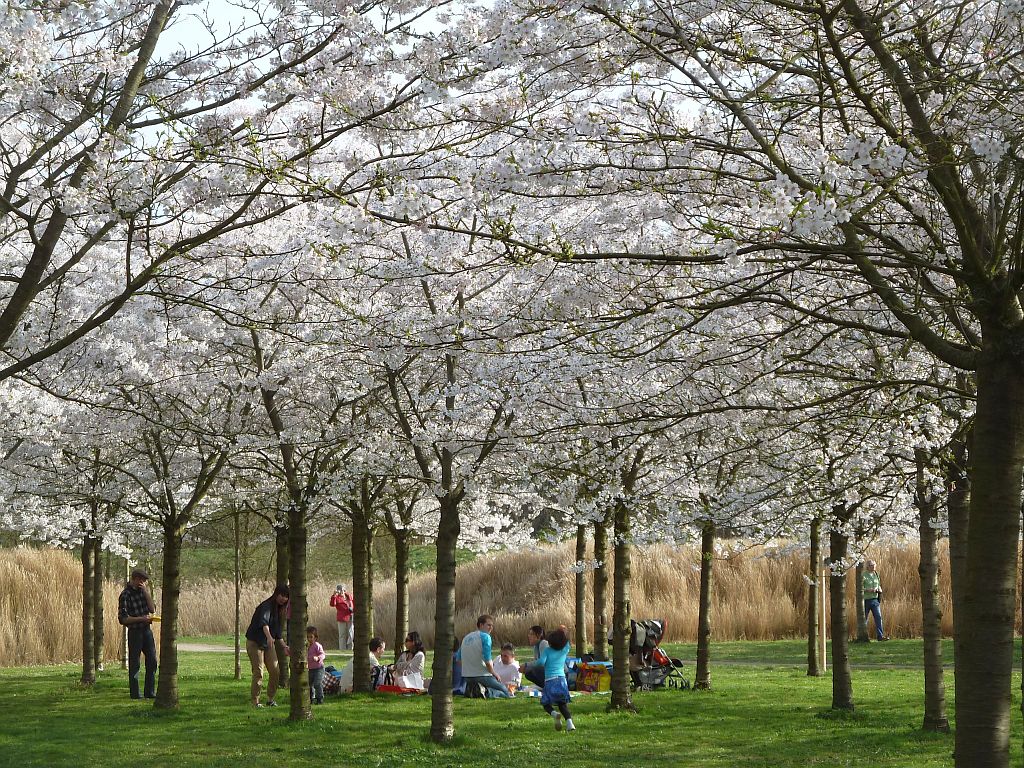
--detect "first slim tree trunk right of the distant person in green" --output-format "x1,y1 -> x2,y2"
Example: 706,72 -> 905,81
914,451 -> 949,733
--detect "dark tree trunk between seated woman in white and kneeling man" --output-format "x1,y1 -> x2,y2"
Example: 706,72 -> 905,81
430,496 -> 462,742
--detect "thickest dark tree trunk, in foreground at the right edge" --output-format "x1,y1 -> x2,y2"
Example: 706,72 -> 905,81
954,360 -> 1024,768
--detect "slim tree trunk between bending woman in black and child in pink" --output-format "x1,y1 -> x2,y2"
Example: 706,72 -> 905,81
285,503 -> 312,720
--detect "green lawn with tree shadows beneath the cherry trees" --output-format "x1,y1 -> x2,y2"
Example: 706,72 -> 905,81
0,641 -> 1022,768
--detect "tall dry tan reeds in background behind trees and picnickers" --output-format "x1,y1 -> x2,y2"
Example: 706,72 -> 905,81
0,544 -> 1020,666
